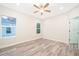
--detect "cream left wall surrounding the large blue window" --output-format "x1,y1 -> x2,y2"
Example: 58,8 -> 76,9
0,6 -> 41,48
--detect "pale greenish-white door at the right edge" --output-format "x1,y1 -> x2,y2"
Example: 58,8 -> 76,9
70,17 -> 79,43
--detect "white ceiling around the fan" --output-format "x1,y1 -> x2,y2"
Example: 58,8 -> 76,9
0,3 -> 79,19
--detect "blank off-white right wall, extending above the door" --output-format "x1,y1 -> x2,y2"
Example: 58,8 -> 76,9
43,6 -> 79,44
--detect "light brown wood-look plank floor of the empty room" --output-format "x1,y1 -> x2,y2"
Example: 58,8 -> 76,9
0,39 -> 74,56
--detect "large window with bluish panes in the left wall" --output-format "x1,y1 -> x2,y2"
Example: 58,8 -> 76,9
0,16 -> 16,37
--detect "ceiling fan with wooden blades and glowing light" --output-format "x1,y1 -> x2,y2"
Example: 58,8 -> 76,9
33,3 -> 51,15
